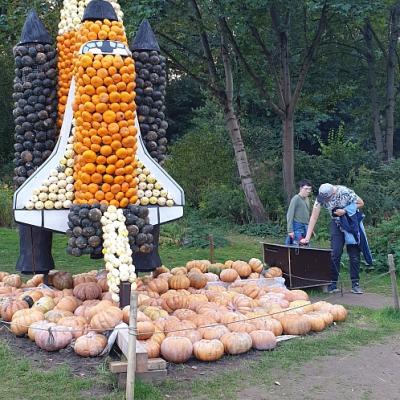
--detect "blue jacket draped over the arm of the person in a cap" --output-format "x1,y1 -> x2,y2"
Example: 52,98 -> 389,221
337,203 -> 373,265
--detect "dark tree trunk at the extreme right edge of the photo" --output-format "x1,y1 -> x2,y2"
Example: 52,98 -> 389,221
386,4 -> 400,160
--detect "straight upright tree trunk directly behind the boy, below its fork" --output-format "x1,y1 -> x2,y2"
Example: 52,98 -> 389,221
282,114 -> 294,202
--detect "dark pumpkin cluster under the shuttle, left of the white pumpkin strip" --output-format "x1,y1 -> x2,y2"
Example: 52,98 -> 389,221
66,204 -> 107,258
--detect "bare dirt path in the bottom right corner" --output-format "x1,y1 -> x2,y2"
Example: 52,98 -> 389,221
237,335 -> 400,400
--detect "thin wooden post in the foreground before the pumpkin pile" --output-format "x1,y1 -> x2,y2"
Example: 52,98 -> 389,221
126,290 -> 137,400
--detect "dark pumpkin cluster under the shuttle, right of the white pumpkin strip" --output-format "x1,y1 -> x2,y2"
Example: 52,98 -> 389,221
124,204 -> 154,257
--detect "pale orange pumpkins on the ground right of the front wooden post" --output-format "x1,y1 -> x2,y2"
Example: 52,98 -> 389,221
130,259 -> 347,363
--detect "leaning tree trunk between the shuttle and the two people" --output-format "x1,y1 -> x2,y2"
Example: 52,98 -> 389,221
224,106 -> 267,224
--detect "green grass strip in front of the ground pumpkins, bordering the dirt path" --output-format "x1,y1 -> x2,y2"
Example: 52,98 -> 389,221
0,307 -> 400,400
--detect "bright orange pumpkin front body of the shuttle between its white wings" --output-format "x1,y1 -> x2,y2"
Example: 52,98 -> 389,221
73,5 -> 137,207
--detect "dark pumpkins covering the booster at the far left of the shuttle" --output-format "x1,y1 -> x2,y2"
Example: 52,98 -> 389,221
13,43 -> 57,186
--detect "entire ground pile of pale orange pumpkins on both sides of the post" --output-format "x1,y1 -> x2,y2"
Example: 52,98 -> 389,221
0,259 -> 347,363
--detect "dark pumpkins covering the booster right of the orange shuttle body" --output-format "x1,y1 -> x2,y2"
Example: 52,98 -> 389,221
133,50 -> 168,164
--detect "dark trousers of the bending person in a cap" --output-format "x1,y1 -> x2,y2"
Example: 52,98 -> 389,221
329,220 -> 360,285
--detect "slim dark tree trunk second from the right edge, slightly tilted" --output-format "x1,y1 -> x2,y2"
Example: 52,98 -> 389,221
362,22 -> 383,157
